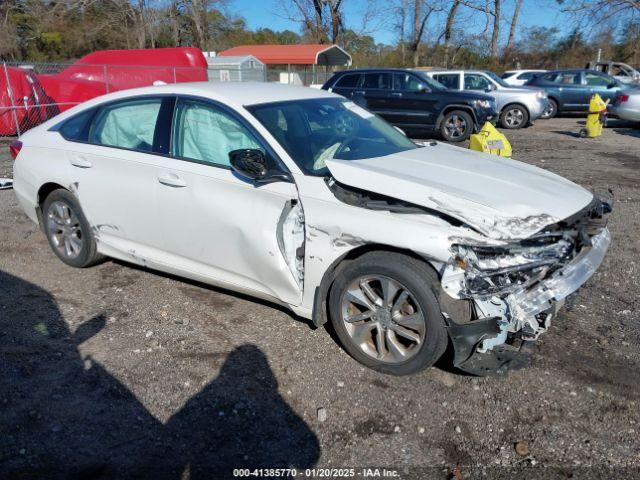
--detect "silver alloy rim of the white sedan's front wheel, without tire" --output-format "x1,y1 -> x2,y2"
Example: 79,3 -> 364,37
341,275 -> 426,363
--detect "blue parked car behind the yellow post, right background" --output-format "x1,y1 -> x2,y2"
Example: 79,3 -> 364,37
527,69 -> 623,118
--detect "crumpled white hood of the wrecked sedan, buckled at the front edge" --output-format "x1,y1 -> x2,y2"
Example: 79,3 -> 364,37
327,142 -> 593,240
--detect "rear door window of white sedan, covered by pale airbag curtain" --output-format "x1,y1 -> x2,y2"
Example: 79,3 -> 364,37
89,98 -> 162,152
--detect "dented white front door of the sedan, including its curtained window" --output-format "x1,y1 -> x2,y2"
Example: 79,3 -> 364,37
158,99 -> 301,304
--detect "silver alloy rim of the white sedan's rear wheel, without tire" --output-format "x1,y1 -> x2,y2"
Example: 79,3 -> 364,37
46,200 -> 83,259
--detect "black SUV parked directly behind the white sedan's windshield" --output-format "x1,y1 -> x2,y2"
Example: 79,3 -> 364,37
322,68 -> 497,142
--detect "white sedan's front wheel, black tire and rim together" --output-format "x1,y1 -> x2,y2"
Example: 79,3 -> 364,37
328,252 -> 447,375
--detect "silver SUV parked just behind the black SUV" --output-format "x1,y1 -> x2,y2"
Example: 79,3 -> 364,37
425,70 -> 547,128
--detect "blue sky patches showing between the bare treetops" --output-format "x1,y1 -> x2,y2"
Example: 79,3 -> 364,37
228,0 -> 569,44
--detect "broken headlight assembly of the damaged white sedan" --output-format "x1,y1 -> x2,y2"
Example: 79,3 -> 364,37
447,239 -> 573,298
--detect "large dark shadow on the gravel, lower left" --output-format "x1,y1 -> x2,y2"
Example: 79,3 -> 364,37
0,272 -> 320,479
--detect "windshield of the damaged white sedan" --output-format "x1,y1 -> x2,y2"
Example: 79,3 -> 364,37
247,98 -> 418,176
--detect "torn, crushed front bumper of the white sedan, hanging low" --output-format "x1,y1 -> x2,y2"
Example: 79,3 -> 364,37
447,228 -> 611,375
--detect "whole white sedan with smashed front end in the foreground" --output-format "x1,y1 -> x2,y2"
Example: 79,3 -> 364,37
12,83 -> 611,375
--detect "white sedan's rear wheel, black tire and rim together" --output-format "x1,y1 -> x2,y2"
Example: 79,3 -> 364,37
42,189 -> 104,268
